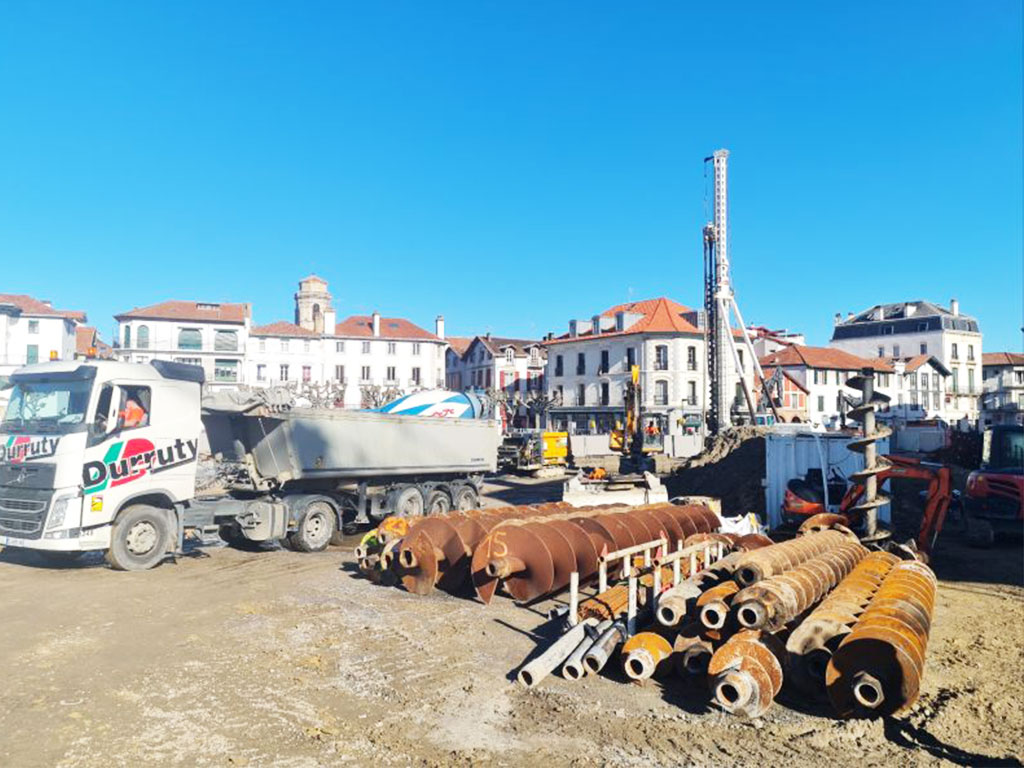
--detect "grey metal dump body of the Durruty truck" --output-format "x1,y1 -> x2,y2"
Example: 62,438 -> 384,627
204,393 -> 501,484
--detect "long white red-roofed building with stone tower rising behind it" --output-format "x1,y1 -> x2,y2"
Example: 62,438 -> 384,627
245,275 -> 446,408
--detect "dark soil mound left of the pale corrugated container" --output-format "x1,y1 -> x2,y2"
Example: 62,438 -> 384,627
665,427 -> 766,518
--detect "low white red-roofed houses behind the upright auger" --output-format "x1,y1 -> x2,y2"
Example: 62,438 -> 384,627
761,344 -> 949,427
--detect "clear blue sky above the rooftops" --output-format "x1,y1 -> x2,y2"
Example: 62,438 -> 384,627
0,0 -> 1024,350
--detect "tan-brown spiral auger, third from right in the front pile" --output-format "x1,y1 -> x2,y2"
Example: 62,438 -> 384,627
732,539 -> 867,632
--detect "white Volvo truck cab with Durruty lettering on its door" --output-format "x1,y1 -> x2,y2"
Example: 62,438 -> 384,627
0,360 -> 203,569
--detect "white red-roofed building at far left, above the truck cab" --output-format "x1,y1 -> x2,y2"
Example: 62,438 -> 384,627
0,294 -> 86,377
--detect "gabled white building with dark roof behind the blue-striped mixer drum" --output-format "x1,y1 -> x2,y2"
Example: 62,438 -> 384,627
444,334 -> 548,427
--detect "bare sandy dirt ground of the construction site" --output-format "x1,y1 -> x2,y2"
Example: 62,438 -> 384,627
0,478 -> 1024,768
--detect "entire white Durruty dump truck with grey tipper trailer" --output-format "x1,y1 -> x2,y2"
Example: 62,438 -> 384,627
0,360 -> 501,570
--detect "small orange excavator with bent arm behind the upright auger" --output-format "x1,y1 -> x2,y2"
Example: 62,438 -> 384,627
782,456 -> 953,556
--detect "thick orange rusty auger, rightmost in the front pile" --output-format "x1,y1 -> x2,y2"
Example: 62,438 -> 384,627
825,561 -> 936,717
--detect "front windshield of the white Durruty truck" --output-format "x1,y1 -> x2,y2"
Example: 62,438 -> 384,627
0,379 -> 92,432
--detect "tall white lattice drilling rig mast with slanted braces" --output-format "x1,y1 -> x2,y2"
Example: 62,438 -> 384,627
703,150 -> 779,435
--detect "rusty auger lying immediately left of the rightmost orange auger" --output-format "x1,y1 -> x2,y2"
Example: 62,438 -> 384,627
785,552 -> 899,700
